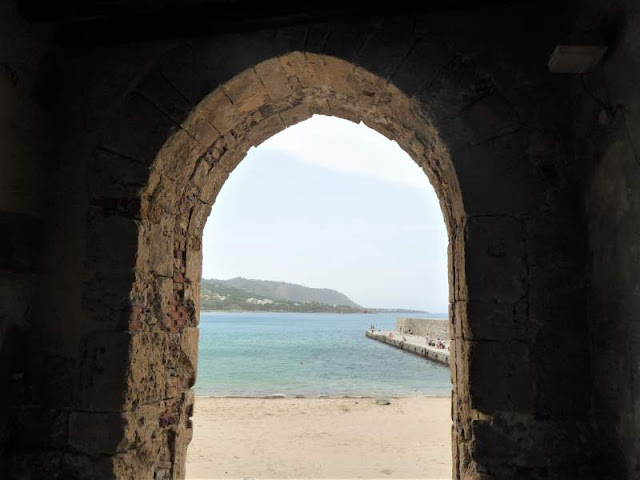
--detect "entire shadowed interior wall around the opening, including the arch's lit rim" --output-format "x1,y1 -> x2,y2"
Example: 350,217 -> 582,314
0,3 -> 640,480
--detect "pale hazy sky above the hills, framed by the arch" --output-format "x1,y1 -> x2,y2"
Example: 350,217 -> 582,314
202,115 -> 448,312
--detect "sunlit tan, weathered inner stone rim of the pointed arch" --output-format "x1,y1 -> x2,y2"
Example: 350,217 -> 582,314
111,52 -> 468,477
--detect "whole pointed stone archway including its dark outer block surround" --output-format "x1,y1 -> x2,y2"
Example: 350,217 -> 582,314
69,14 -> 583,479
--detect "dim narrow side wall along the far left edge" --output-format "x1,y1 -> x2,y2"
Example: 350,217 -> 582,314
0,2 -> 53,478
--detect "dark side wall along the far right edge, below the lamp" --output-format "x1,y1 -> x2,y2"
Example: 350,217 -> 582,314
573,1 -> 640,479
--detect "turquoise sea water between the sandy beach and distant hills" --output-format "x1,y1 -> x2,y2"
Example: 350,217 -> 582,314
195,312 -> 451,397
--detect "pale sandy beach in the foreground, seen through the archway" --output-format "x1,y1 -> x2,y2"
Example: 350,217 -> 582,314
187,397 -> 451,479
